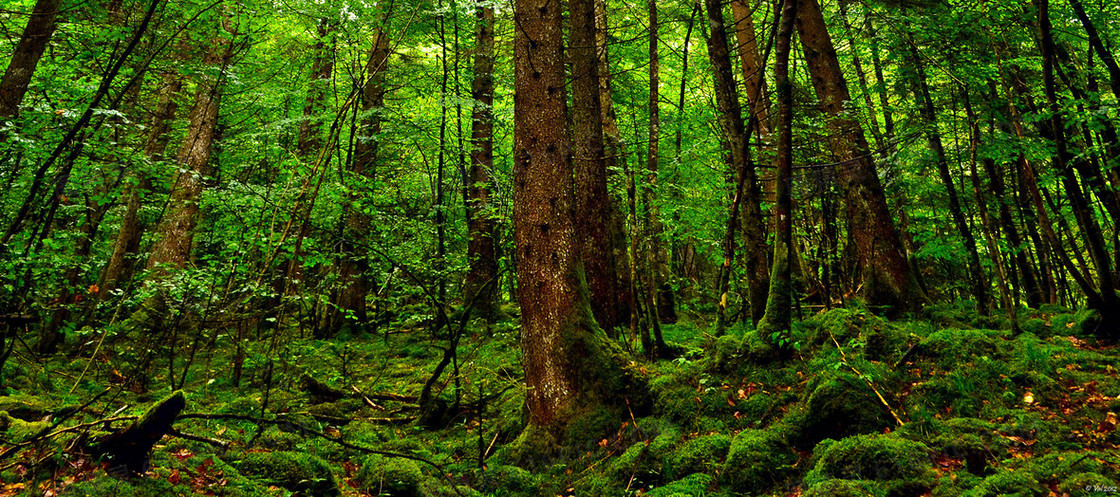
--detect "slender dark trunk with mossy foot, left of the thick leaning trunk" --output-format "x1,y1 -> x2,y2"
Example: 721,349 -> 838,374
758,0 -> 797,339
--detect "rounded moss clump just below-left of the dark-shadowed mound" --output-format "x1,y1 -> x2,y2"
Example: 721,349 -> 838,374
720,430 -> 797,494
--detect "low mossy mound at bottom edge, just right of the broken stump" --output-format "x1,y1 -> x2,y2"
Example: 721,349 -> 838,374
233,451 -> 338,497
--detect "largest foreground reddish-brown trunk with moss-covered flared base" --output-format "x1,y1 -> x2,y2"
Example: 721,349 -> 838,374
514,0 -> 645,449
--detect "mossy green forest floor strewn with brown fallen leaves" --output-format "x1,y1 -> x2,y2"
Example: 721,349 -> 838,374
0,299 -> 1120,496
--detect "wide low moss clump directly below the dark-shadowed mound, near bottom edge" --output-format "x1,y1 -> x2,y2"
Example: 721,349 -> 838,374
805,434 -> 930,484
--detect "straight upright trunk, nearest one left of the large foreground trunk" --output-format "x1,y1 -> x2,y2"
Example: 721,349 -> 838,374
463,7 -> 501,320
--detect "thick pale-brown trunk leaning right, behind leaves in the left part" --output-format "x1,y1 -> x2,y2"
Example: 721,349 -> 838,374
148,38 -> 233,275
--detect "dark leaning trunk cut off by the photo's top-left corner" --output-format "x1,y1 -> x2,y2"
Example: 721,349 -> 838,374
0,0 -> 62,118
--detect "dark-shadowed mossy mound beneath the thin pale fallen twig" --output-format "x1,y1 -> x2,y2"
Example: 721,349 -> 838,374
795,373 -> 892,448
